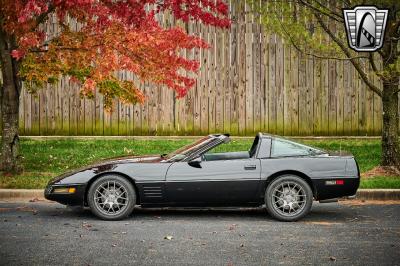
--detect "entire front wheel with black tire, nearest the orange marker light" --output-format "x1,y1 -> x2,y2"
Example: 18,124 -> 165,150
87,175 -> 136,221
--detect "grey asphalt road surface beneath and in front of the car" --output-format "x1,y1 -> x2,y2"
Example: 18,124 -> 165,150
0,202 -> 400,265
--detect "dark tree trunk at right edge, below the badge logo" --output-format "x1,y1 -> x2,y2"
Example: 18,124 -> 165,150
381,82 -> 400,169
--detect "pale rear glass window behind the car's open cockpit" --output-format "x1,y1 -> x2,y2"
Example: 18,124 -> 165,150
271,139 -> 318,157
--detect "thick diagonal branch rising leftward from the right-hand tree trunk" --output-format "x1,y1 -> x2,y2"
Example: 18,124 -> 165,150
313,12 -> 382,97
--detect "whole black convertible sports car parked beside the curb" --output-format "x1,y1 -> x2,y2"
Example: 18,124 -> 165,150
45,133 -> 360,221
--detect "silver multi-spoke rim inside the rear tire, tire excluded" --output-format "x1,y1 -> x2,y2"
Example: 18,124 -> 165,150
271,181 -> 307,216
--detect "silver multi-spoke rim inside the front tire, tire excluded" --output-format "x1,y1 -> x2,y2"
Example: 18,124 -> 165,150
93,180 -> 129,216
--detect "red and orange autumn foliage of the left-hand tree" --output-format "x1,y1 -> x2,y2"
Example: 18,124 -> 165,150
0,0 -> 230,108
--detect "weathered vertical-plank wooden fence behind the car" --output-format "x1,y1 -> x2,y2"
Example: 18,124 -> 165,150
9,0 -> 400,135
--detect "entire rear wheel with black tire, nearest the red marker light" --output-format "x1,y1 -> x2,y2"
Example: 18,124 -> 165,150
265,175 -> 313,222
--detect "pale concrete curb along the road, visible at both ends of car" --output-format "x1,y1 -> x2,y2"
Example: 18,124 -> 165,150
0,189 -> 400,202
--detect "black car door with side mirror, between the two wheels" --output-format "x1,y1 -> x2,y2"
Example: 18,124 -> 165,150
166,158 -> 261,206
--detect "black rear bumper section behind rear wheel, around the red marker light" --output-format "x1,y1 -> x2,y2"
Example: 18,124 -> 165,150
313,177 -> 360,200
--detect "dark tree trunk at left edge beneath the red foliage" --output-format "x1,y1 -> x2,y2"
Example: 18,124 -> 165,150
0,31 -> 22,173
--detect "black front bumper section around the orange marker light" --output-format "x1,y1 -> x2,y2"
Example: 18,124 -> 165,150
44,184 -> 86,206
